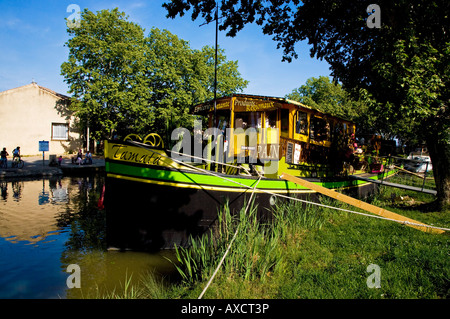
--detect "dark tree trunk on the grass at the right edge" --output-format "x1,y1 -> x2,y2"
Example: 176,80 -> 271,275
427,136 -> 450,210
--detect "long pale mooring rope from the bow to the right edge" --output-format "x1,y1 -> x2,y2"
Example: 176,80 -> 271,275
126,141 -> 450,231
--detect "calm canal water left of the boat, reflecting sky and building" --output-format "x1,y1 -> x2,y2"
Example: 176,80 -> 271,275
0,176 -> 174,299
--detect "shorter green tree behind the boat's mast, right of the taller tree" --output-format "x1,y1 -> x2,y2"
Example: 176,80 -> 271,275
146,28 -> 248,141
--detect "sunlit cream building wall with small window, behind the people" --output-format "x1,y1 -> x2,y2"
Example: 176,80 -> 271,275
0,83 -> 82,156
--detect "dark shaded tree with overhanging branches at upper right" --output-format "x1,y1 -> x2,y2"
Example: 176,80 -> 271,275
164,0 -> 450,207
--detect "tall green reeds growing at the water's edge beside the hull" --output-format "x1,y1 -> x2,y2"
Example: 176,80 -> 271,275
169,196 -> 325,284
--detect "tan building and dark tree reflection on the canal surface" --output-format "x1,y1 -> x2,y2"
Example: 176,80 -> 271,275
0,177 -> 105,245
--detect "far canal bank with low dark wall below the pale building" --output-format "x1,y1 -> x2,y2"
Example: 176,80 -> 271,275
0,155 -> 105,180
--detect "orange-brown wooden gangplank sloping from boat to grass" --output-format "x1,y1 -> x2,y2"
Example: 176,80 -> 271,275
281,173 -> 445,234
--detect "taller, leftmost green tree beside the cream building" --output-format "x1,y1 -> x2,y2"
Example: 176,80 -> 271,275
61,9 -> 154,139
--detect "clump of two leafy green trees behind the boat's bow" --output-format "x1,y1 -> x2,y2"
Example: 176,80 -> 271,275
61,9 -> 248,139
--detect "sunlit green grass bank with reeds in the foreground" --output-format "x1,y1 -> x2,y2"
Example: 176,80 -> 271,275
103,174 -> 450,299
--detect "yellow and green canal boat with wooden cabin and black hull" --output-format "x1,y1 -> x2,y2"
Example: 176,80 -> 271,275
105,94 -> 392,249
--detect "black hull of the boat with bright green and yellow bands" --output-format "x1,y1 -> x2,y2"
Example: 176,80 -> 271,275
105,144 -> 392,250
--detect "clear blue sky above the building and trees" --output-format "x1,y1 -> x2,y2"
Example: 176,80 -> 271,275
0,0 -> 330,97
